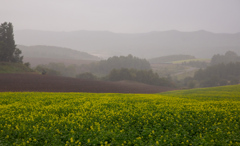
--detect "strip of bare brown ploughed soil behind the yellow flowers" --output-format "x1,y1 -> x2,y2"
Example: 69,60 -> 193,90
0,74 -> 174,93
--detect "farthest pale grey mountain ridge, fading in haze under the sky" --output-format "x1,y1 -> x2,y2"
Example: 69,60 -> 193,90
15,30 -> 240,59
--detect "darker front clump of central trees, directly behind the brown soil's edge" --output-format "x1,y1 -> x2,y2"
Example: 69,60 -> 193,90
108,68 -> 173,86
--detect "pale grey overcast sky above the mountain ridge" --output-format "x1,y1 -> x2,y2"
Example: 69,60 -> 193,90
0,0 -> 240,33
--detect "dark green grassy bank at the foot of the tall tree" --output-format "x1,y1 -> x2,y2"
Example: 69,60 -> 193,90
0,62 -> 33,73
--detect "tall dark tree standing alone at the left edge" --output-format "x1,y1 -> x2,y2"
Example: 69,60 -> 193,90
0,22 -> 23,63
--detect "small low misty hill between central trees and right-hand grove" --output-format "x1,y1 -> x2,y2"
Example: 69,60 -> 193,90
148,55 -> 195,63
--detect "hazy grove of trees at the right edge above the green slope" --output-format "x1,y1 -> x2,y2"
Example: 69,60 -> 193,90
183,51 -> 240,88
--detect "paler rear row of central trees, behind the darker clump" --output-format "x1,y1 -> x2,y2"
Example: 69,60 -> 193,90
36,55 -> 151,77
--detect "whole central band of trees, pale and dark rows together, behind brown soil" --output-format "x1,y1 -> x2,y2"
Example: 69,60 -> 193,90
35,55 -> 174,86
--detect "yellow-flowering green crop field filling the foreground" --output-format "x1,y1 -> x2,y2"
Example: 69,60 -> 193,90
0,85 -> 240,145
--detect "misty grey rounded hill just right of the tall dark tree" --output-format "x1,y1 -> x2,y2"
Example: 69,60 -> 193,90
17,45 -> 100,66
